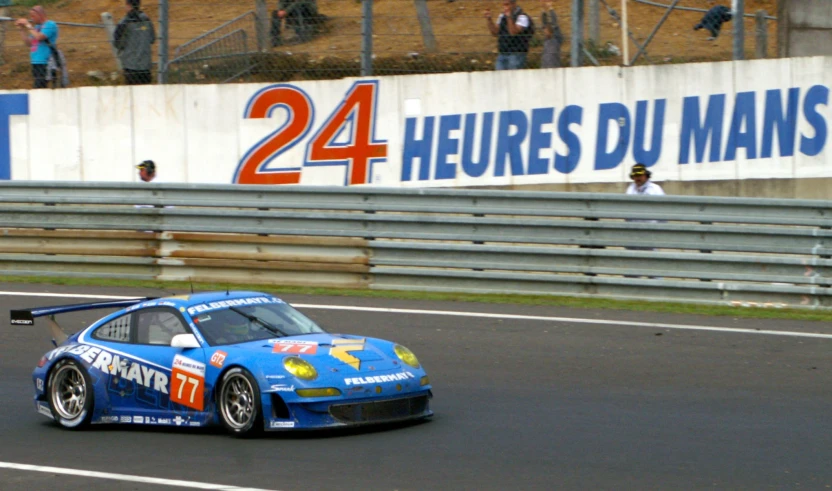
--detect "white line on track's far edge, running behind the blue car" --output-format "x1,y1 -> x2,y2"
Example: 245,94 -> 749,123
0,291 -> 832,339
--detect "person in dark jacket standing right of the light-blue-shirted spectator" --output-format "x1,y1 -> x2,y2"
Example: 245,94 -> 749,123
113,0 -> 156,85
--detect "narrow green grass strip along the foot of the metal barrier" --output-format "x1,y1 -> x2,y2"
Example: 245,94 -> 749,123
0,276 -> 832,322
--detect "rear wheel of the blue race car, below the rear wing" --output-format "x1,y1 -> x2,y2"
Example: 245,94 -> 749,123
46,359 -> 95,430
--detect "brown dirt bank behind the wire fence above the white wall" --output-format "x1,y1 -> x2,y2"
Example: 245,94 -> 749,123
0,0 -> 777,89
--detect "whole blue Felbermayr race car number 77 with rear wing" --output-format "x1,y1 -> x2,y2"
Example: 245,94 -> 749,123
11,291 -> 433,436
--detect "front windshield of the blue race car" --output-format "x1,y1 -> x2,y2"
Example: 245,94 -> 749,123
193,303 -> 326,346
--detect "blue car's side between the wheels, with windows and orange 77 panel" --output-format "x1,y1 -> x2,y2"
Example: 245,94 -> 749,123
92,307 -> 208,424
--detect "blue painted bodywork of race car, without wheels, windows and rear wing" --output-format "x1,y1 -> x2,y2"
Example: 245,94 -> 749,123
33,292 -> 433,430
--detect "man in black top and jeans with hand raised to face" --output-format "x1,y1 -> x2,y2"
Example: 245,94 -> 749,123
485,0 -> 534,70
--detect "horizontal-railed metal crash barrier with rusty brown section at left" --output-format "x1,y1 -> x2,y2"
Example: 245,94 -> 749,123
0,181 -> 832,308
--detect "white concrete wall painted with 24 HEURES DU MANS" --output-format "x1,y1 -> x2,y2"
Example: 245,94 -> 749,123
0,57 -> 832,187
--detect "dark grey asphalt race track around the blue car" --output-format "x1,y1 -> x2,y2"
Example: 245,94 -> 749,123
0,284 -> 832,491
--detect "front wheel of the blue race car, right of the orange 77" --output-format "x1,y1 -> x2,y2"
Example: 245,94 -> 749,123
217,367 -> 263,438
